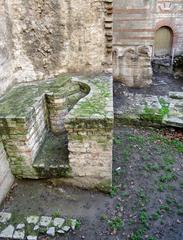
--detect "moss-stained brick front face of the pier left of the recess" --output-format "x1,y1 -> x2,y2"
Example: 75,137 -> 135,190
0,117 -> 41,178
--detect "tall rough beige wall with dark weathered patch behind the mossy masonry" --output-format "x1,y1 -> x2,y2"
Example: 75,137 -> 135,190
0,0 -> 112,94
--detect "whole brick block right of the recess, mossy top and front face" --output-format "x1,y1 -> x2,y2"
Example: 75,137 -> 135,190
65,76 -> 113,191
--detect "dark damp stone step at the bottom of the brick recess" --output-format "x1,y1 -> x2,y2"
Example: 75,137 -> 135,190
33,132 -> 70,178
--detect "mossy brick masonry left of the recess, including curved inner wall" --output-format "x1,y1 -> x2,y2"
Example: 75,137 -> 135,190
0,75 -> 86,178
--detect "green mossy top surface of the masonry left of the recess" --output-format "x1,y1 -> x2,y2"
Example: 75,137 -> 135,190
0,76 -> 80,118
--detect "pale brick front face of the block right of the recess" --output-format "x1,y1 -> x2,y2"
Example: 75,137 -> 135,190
67,120 -> 113,192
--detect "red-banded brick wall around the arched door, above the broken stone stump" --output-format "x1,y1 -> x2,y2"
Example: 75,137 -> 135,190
113,0 -> 183,54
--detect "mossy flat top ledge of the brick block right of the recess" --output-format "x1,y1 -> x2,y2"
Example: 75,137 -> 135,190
65,77 -> 114,129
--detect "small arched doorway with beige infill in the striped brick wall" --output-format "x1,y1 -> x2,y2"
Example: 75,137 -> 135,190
154,26 -> 173,57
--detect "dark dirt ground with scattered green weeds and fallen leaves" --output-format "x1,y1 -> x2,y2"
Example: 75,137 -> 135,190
0,126 -> 183,240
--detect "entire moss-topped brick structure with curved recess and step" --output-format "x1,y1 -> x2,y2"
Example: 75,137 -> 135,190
0,76 -> 113,191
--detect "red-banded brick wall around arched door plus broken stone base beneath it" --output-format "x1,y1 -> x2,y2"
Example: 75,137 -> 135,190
113,0 -> 183,87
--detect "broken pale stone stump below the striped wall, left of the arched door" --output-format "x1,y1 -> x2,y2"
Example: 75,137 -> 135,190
113,46 -> 152,87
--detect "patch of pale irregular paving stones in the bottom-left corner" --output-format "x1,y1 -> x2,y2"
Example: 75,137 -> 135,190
0,212 -> 78,240
